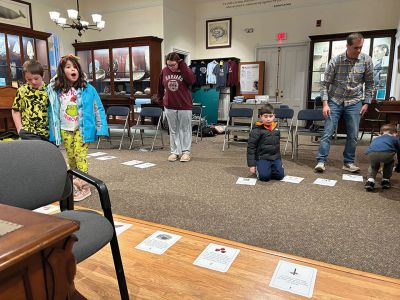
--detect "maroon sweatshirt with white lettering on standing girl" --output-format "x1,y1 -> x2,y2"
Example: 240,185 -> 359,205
158,60 -> 196,110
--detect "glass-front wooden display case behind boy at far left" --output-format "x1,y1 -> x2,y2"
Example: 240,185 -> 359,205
0,24 -> 50,87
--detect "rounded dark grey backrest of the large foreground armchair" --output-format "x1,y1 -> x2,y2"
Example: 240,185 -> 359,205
0,141 -> 68,210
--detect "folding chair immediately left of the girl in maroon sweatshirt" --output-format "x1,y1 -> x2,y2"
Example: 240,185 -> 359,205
129,107 -> 164,151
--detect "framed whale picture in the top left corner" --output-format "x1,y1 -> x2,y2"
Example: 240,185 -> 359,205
0,0 -> 33,29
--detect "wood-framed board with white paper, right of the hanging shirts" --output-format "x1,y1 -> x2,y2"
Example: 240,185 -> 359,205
238,61 -> 265,98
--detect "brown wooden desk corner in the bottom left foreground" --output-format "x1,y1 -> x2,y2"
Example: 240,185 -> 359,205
0,204 -> 79,300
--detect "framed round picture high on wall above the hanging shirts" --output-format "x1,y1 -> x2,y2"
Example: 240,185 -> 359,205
206,18 -> 232,49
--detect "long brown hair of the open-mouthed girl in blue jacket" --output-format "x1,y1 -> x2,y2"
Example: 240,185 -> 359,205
54,54 -> 87,92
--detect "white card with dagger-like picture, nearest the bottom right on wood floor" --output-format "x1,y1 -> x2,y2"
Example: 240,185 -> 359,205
269,260 -> 317,298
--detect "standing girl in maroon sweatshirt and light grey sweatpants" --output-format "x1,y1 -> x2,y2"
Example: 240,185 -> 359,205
158,52 -> 196,162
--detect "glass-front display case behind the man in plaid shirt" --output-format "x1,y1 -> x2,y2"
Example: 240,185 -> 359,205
308,29 -> 396,108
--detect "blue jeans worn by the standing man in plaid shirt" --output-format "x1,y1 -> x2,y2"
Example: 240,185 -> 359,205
317,100 -> 362,164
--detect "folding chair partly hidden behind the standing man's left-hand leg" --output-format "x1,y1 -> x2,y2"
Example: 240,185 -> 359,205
292,109 -> 325,159
